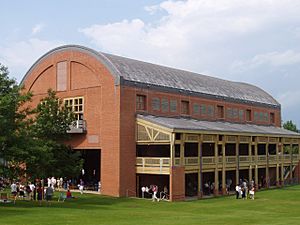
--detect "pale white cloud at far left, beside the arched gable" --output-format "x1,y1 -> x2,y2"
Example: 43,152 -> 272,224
0,38 -> 63,81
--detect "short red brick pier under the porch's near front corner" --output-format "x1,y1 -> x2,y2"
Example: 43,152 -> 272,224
170,166 -> 185,201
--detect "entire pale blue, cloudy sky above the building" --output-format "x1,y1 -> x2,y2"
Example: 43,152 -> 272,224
0,0 -> 300,128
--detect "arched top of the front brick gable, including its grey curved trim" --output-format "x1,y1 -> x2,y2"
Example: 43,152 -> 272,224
21,45 -> 120,94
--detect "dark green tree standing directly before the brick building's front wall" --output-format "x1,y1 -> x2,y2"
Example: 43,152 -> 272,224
26,90 -> 83,177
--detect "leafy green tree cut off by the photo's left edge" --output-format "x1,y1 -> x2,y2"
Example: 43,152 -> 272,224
0,63 -> 31,178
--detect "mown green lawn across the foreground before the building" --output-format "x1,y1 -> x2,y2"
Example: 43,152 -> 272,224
0,185 -> 300,225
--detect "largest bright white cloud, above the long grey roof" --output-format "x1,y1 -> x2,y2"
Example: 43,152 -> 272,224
79,0 -> 300,74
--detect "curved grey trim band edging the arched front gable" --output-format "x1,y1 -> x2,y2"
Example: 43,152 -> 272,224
20,45 -> 122,85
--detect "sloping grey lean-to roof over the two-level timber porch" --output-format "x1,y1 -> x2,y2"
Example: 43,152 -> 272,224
137,114 -> 300,138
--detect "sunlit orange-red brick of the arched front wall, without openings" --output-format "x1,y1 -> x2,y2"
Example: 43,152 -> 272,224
23,50 -> 120,196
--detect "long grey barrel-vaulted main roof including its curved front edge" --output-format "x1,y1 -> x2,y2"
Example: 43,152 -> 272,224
22,45 -> 280,108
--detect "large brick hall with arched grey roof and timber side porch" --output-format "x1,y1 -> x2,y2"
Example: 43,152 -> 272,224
22,45 -> 300,201
